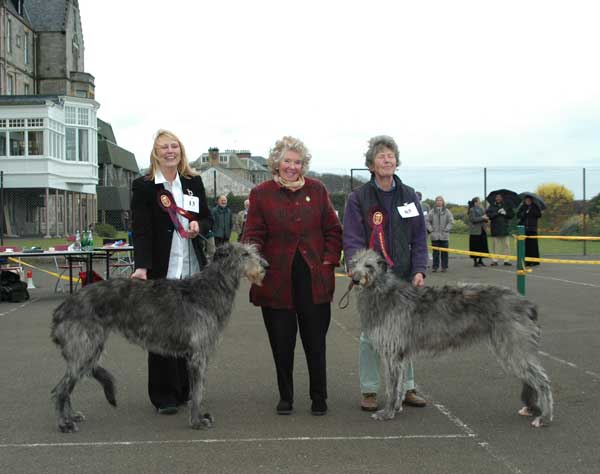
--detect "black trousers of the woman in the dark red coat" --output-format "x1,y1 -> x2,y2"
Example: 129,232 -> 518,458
262,252 -> 331,402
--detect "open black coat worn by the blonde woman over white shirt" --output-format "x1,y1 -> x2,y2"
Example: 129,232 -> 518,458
131,176 -> 213,279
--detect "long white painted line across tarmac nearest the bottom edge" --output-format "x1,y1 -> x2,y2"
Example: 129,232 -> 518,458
0,433 -> 474,449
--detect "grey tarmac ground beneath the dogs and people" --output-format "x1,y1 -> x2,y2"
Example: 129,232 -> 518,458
0,258 -> 600,474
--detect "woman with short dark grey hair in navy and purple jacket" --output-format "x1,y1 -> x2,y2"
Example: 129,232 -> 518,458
343,135 -> 427,411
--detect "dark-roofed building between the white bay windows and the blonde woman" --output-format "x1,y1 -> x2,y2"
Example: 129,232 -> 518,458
96,119 -> 140,230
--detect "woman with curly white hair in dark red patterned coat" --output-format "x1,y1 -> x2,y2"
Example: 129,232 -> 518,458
243,137 -> 342,415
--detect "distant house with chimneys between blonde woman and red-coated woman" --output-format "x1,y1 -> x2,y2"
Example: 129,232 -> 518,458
191,148 -> 271,196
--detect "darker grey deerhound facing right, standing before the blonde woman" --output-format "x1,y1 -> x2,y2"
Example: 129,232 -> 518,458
51,243 -> 267,433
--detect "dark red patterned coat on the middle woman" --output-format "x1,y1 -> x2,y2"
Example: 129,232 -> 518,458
243,178 -> 342,309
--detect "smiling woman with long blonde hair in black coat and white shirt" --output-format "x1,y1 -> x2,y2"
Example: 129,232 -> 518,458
131,130 -> 212,414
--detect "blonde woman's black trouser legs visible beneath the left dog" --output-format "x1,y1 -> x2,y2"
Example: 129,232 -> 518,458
148,352 -> 190,408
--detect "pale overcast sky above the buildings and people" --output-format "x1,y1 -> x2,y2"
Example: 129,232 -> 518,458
79,0 -> 600,199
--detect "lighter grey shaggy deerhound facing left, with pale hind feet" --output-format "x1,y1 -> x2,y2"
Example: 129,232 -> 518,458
350,250 -> 553,427
